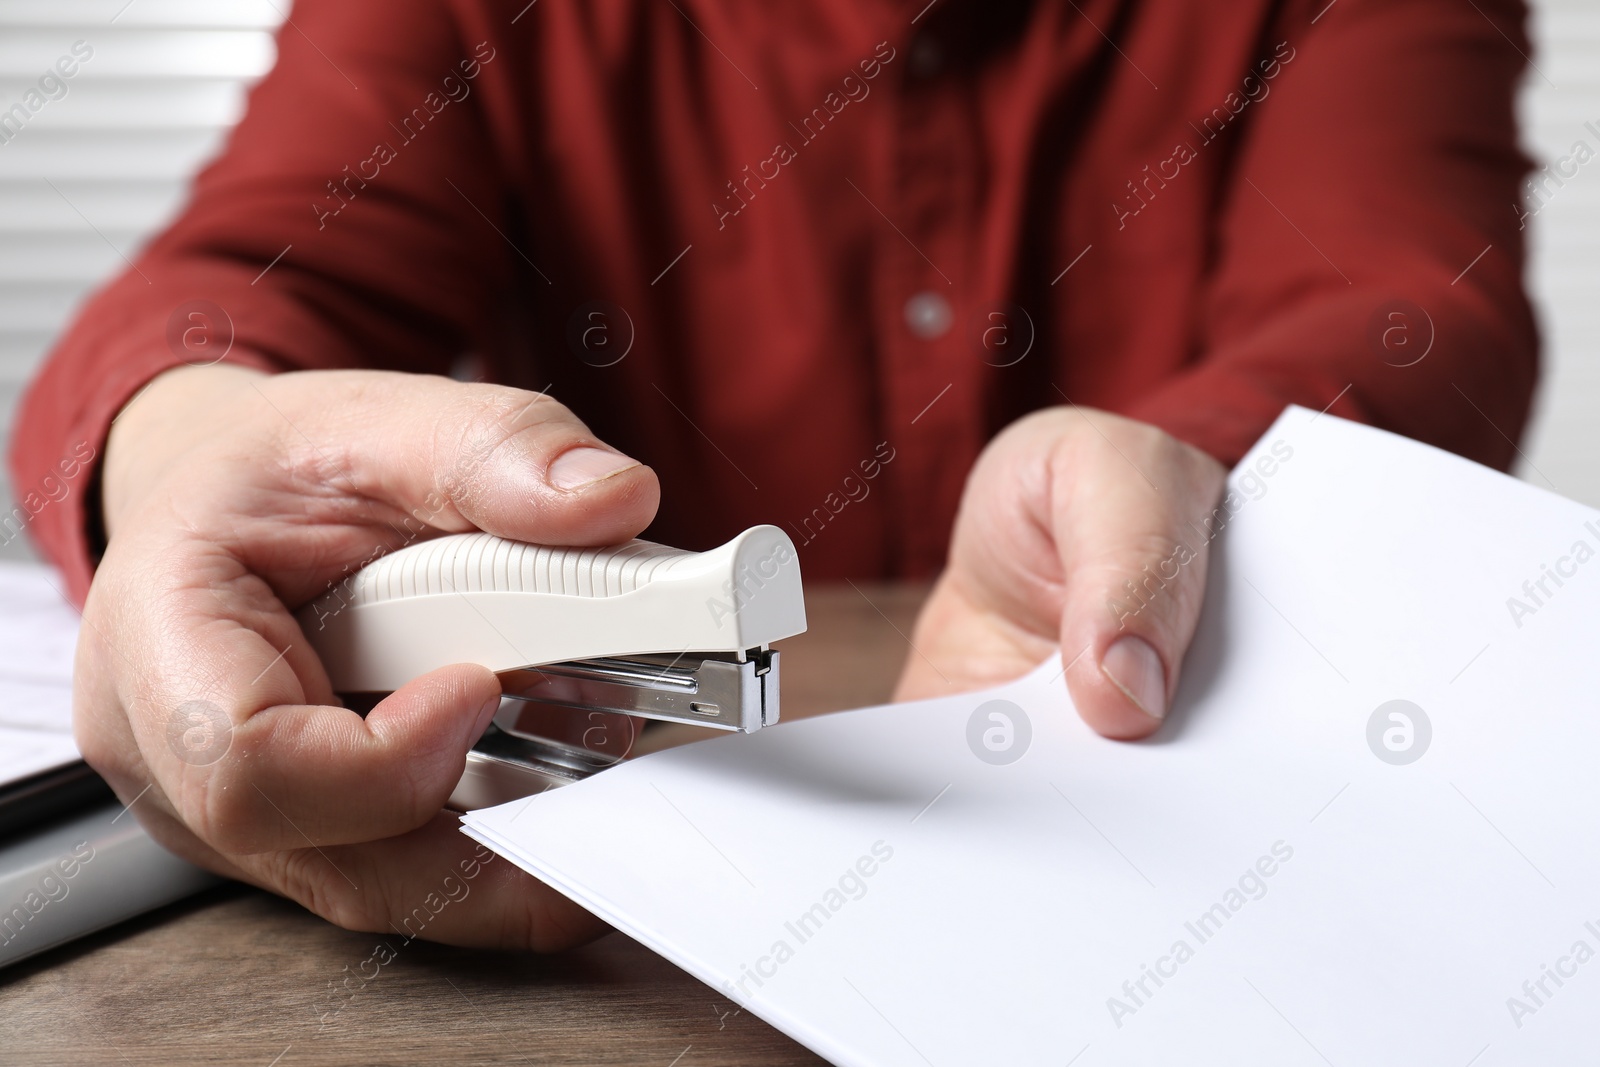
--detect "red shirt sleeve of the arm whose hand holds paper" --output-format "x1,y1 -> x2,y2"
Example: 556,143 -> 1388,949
1128,0 -> 1538,469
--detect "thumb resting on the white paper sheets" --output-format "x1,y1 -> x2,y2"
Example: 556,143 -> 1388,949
1053,427 -> 1226,739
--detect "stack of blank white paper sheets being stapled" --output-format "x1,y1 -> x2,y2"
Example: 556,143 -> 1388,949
464,408 -> 1600,1067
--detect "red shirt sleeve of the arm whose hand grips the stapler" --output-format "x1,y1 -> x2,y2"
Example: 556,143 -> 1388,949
10,0 -> 515,603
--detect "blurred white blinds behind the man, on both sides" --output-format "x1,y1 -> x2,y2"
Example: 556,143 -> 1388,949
0,0 -> 1600,558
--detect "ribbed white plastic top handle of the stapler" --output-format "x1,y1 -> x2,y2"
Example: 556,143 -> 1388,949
299,526 -> 805,693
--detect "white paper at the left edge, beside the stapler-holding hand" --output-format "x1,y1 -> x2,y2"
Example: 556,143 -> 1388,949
0,563 -> 78,787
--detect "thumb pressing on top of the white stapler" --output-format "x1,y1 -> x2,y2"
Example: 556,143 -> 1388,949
291,371 -> 661,545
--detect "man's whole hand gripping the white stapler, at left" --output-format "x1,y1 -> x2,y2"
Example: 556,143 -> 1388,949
74,365 -> 659,949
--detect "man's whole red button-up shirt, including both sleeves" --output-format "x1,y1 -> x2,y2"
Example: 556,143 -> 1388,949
11,0 -> 1536,598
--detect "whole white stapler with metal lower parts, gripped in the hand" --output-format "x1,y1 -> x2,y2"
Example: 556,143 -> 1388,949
298,526 -> 805,811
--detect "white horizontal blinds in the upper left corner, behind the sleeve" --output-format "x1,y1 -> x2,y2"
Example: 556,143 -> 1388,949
0,0 -> 286,555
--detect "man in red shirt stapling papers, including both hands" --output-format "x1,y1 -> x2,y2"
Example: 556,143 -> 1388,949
13,0 -> 1536,947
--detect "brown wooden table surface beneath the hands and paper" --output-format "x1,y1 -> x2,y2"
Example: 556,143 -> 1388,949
0,584 -> 926,1067
